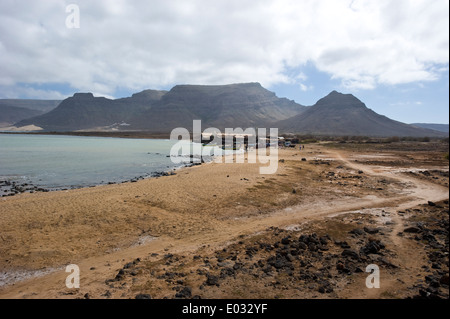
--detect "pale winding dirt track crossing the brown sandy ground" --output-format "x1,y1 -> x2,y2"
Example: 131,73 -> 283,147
0,150 -> 448,298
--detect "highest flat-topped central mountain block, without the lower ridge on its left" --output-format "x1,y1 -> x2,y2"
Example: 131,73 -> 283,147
132,83 -> 305,131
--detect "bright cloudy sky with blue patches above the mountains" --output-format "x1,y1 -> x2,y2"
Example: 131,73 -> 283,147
0,0 -> 449,123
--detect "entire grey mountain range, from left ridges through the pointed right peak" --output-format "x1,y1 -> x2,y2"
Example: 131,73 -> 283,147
5,83 -> 448,137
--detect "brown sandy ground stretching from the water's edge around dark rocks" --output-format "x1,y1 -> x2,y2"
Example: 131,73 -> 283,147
0,144 -> 448,298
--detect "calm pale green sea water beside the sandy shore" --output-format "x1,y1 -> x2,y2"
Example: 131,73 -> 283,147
0,134 -> 197,189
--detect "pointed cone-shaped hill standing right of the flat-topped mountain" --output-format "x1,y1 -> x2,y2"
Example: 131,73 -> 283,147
277,91 -> 444,137
